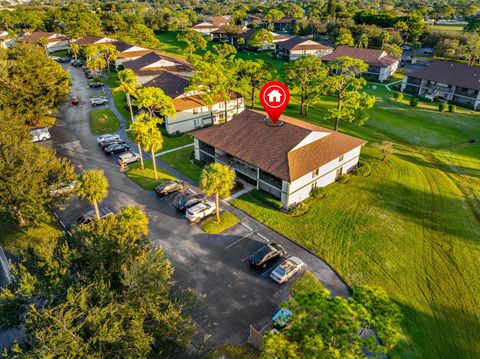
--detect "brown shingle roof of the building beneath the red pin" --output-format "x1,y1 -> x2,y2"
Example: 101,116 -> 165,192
191,110 -> 365,182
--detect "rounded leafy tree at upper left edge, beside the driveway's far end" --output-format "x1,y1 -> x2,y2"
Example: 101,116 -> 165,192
0,43 -> 70,125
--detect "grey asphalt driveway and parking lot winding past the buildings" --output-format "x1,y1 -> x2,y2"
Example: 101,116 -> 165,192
51,65 -> 350,351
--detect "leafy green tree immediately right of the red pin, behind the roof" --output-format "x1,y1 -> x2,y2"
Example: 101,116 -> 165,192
285,55 -> 328,116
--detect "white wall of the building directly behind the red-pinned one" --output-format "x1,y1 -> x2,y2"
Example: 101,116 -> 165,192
165,98 -> 245,134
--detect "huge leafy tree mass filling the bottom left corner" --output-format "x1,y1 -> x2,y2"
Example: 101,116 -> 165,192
0,207 -> 198,358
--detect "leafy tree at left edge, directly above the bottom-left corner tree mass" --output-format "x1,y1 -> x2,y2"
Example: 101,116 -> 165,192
0,115 -> 75,227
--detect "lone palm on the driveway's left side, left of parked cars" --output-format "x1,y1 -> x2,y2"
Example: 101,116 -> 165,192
75,169 -> 108,219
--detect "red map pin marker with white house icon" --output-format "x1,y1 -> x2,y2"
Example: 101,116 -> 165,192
260,81 -> 290,123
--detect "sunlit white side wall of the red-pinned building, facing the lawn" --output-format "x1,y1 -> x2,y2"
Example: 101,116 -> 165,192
282,146 -> 361,208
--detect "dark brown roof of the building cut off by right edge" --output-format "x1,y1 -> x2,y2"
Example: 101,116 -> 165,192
406,61 -> 480,90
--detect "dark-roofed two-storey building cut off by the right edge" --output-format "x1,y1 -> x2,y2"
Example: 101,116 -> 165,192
401,61 -> 480,110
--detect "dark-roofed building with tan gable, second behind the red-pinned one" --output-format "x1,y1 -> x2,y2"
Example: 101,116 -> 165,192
122,51 -> 194,85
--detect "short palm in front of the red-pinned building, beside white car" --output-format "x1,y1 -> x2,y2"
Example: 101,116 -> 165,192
200,163 -> 235,223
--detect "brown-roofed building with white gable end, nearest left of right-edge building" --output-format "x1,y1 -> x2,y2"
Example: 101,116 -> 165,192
322,46 -> 400,82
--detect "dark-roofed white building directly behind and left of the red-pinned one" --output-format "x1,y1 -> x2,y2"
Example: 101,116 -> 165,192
143,71 -> 245,134
